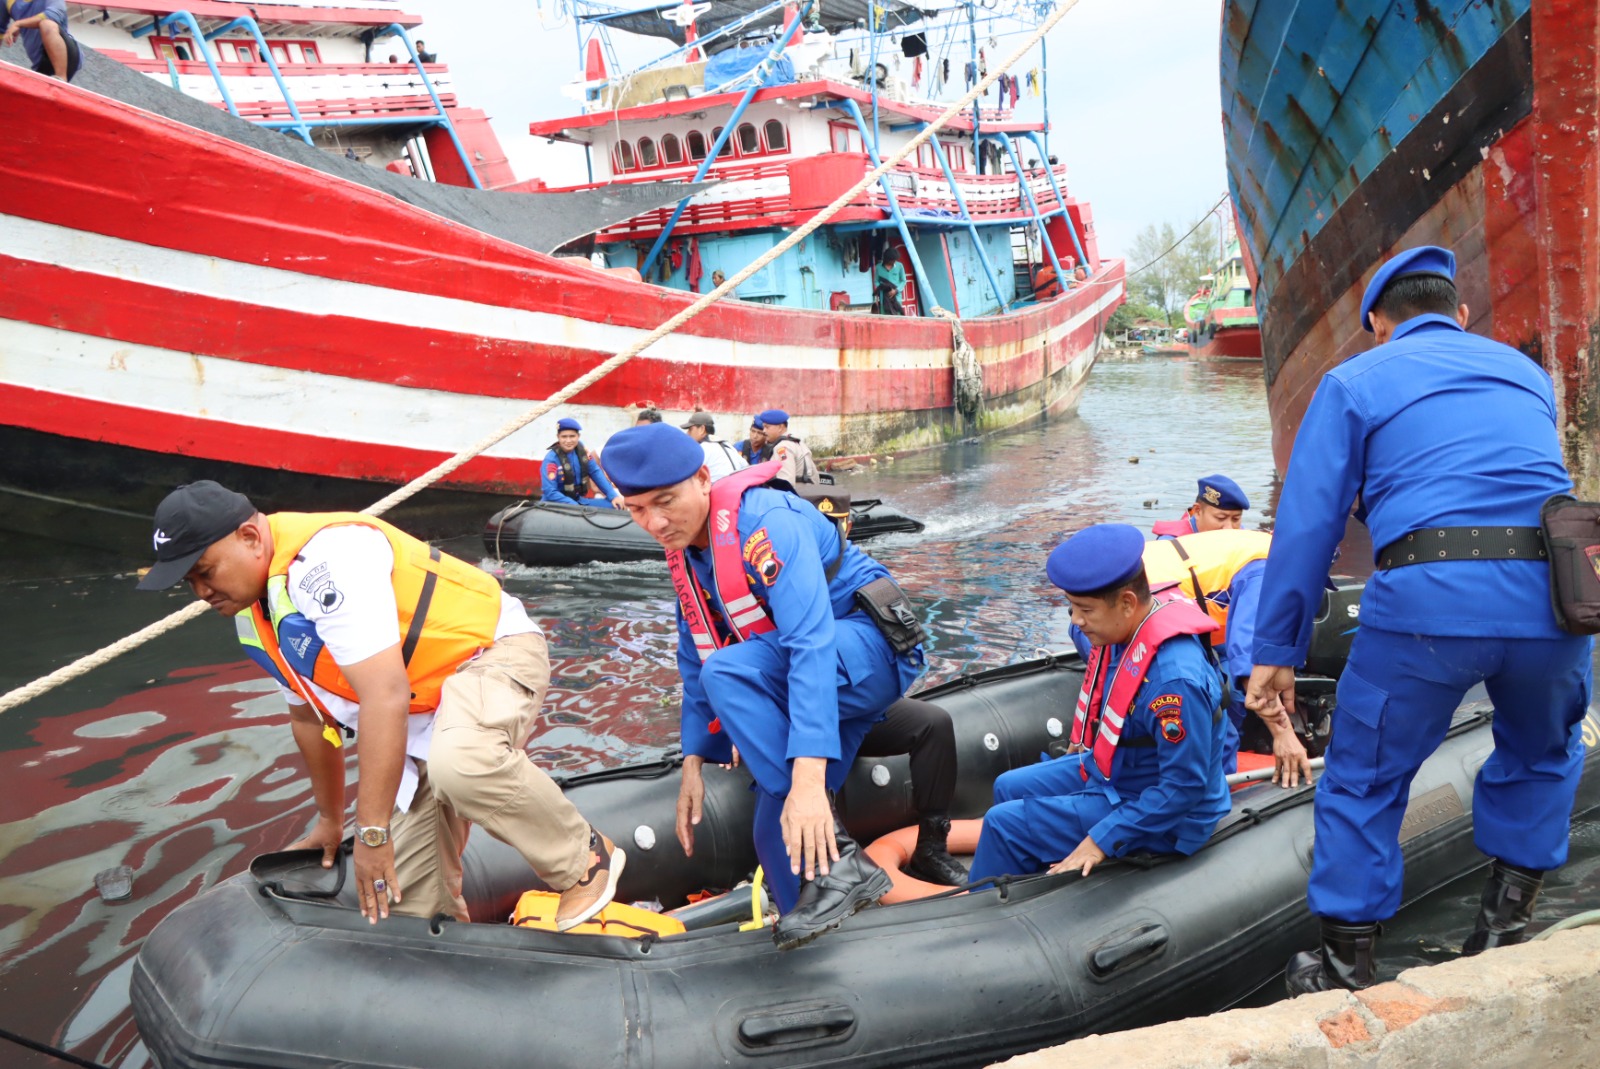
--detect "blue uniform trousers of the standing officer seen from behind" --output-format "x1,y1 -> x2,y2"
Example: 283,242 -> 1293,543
1307,624 -> 1592,923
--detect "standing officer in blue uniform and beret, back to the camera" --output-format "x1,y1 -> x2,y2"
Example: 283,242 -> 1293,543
1248,246 -> 1590,994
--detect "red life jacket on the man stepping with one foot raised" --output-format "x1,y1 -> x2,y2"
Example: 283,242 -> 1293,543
667,461 -> 782,661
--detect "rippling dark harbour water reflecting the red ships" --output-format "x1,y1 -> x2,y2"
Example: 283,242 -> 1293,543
0,358 -> 1600,1069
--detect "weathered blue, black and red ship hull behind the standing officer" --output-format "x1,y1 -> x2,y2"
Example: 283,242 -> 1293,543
1221,0 -> 1600,494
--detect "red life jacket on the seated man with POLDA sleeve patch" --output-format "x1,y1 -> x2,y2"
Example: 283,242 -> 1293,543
1070,594 -> 1218,783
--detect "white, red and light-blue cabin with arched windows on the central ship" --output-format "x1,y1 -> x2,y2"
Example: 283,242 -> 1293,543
530,0 -> 1099,317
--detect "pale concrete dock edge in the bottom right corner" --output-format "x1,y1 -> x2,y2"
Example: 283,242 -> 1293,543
995,927 -> 1600,1069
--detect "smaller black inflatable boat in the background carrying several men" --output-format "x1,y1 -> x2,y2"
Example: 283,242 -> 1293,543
483,498 -> 923,567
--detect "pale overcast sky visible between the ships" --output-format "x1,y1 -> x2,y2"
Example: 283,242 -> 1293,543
400,0 -> 1227,254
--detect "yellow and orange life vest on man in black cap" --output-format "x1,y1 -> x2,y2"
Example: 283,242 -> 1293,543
235,512 -> 501,729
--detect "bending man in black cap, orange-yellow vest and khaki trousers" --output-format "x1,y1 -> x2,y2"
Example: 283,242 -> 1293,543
139,482 -> 626,931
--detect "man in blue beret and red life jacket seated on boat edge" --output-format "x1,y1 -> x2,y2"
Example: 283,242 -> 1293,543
971,523 -> 1229,880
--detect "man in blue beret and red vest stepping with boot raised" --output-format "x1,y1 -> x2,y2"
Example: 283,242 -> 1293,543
605,426 -> 923,949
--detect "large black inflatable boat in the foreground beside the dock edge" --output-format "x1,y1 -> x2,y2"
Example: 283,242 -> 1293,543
133,585 -> 1600,1069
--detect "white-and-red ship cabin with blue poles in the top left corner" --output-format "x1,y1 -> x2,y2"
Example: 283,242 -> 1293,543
67,0 -> 515,189
